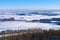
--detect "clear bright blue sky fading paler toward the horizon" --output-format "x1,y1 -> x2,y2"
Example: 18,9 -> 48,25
0,0 -> 60,9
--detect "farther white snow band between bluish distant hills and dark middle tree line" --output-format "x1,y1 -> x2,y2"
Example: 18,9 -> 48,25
0,15 -> 60,20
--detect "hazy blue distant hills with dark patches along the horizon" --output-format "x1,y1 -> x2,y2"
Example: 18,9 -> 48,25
0,10 -> 60,16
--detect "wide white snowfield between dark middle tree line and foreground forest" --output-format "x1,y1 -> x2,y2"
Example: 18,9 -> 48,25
0,21 -> 60,30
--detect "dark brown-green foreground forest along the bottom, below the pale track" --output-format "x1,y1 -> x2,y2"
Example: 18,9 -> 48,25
1,29 -> 60,40
